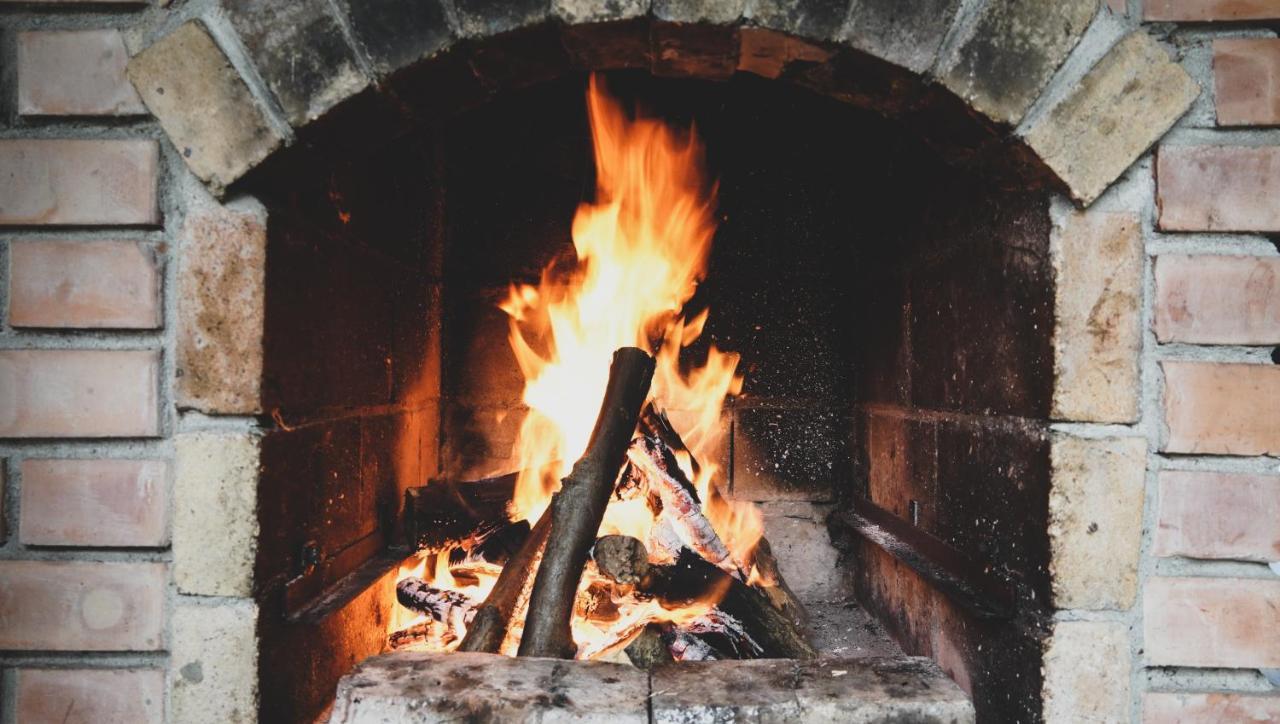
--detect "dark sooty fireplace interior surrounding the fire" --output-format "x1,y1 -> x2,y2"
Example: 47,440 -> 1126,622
246,72 -> 1053,721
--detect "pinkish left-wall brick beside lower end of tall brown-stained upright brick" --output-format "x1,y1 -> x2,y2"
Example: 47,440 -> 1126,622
0,349 -> 160,437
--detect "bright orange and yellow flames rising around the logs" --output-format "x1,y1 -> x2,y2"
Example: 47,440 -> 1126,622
397,77 -> 763,657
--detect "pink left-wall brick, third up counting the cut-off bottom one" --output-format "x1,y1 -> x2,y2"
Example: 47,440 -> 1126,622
18,459 -> 169,546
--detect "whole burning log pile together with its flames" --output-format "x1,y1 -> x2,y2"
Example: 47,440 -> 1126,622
389,78 -> 814,666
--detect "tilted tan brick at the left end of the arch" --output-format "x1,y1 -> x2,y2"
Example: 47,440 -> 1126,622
129,20 -> 284,189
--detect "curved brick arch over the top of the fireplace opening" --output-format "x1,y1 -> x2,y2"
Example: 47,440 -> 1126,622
129,0 -> 1198,203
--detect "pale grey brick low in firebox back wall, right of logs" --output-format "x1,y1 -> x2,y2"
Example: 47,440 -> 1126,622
760,501 -> 849,601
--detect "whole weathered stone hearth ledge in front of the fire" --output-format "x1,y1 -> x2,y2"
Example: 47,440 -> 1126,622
330,652 -> 974,724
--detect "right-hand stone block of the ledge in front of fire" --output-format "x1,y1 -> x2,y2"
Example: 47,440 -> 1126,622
650,656 -> 974,724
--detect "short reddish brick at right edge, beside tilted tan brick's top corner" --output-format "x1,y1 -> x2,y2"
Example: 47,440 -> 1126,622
1213,37 -> 1280,125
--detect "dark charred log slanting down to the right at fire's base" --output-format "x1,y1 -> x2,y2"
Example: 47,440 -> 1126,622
637,549 -> 818,659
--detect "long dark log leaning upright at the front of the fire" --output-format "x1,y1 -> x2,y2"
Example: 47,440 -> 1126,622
520,347 -> 654,659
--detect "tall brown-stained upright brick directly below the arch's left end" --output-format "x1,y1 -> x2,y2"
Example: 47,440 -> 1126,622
177,199 -> 266,414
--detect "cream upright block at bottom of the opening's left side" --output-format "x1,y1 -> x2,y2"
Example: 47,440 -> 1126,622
169,596 -> 259,724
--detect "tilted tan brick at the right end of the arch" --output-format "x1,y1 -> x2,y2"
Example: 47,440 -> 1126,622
1025,31 -> 1199,203
